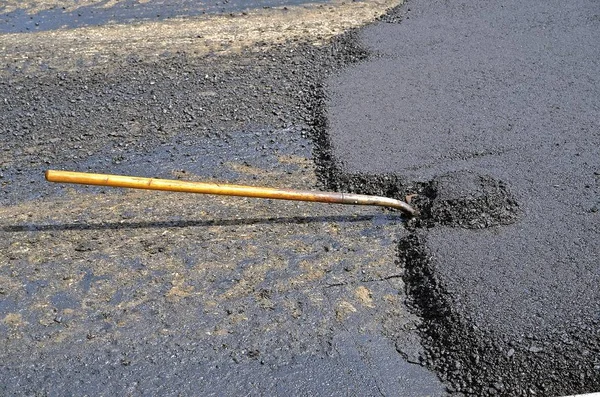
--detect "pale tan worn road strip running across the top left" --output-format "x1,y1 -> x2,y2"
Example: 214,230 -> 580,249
0,0 -> 400,73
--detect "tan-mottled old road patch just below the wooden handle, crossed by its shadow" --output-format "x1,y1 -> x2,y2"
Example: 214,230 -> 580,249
0,164 -> 418,362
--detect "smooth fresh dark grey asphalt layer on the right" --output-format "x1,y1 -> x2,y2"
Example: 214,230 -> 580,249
323,0 -> 600,395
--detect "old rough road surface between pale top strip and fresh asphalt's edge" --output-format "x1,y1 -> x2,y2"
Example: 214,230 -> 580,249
0,15 -> 445,396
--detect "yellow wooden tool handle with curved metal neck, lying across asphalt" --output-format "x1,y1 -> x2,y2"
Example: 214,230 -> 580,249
46,170 -> 416,216
